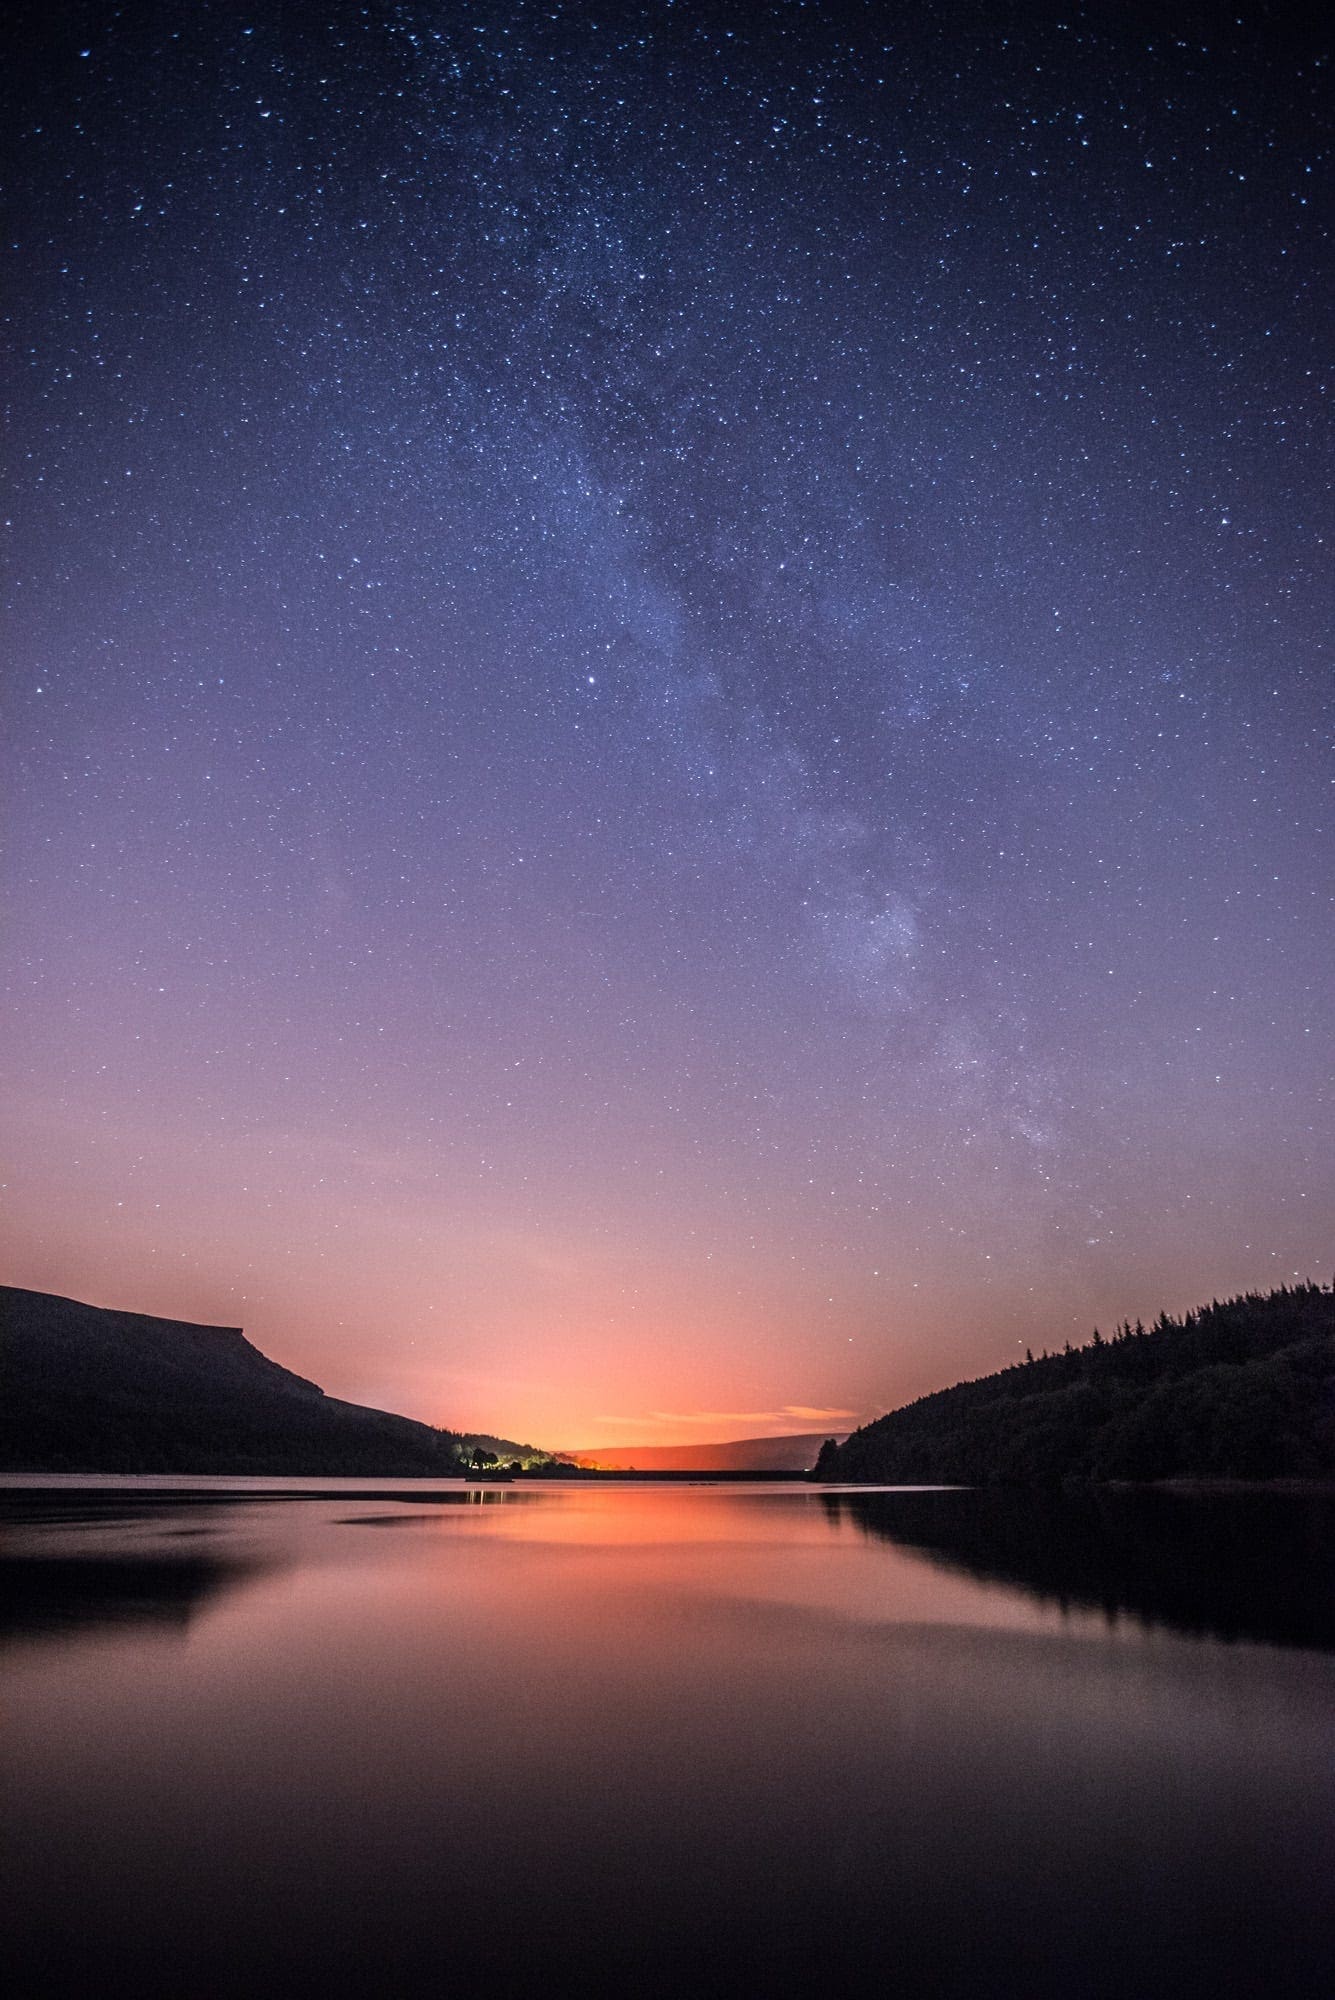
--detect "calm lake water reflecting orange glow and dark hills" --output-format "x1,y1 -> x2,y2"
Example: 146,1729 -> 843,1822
0,1482 -> 1335,2000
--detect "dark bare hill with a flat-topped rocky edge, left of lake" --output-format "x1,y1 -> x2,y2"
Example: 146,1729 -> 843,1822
0,1286 -> 520,1478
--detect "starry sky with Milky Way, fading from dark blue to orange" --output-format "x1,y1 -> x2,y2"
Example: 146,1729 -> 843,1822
0,0 -> 1335,1446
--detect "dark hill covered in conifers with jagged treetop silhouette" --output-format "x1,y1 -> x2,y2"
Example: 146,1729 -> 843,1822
815,1284 -> 1335,1486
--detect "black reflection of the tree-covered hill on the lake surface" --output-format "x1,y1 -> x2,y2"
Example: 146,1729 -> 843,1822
821,1490 -> 1335,1650
